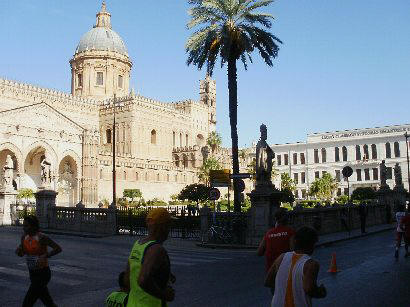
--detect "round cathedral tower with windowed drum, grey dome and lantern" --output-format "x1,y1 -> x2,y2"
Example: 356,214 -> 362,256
70,1 -> 132,100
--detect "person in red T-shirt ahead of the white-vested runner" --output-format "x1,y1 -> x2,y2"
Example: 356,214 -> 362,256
257,208 -> 295,272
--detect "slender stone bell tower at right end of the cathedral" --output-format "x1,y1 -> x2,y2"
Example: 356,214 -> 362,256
199,74 -> 216,132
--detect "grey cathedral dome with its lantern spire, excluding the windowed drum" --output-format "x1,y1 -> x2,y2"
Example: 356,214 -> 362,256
75,1 -> 128,57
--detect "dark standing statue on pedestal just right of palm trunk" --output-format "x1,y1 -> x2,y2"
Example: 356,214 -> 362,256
255,124 -> 275,185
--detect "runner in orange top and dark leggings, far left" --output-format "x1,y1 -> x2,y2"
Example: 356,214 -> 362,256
16,215 -> 62,307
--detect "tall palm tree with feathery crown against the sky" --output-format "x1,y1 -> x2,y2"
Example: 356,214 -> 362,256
185,0 -> 282,212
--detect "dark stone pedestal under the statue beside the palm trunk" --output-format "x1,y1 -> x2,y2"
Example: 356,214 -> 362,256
246,185 -> 282,245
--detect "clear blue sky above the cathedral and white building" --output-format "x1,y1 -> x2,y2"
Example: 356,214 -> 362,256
0,0 -> 410,146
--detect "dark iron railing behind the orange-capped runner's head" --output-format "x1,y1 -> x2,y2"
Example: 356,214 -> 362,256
116,207 -> 201,240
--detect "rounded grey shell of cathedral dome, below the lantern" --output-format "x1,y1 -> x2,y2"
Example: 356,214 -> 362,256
75,27 -> 128,56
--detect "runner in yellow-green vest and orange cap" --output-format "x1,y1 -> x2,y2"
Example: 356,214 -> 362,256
126,208 -> 175,307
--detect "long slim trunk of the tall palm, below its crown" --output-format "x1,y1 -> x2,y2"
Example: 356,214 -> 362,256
228,57 -> 241,212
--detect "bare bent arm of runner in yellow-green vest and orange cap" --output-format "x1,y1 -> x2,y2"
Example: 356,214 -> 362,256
138,244 -> 174,301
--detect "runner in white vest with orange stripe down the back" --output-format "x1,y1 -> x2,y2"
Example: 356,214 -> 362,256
265,227 -> 327,307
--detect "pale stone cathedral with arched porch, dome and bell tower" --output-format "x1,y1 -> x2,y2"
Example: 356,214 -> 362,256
0,2 -> 216,207
